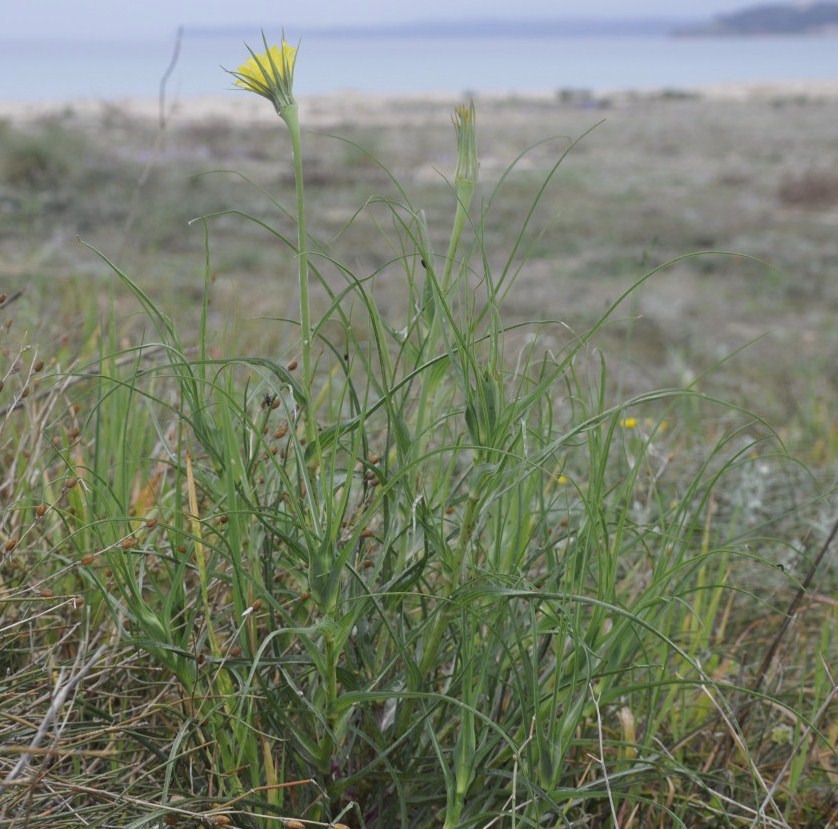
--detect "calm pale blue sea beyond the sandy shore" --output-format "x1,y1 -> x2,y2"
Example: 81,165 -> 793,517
0,31 -> 838,101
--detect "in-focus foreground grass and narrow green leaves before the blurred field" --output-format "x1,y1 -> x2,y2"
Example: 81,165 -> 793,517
0,90 -> 838,829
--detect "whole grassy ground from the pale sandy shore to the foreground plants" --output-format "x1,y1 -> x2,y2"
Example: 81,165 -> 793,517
0,79 -> 838,829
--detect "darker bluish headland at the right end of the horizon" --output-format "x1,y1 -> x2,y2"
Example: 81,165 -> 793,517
675,3 -> 838,36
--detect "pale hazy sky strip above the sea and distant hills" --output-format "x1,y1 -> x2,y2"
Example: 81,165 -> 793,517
0,0 -> 753,39
